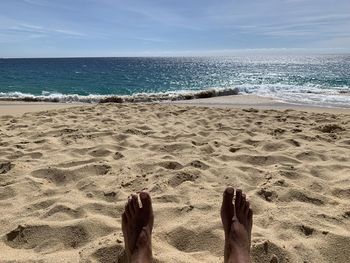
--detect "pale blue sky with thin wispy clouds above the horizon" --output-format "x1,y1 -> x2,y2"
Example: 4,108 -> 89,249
0,0 -> 350,57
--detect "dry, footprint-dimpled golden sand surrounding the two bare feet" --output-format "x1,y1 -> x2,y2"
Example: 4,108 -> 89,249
0,100 -> 350,263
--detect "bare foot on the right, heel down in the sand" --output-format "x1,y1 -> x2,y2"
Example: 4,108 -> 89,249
221,187 -> 253,263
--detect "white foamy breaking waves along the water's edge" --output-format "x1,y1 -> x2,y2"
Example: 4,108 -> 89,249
0,84 -> 350,107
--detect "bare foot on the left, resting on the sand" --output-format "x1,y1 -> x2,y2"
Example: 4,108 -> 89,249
122,192 -> 154,263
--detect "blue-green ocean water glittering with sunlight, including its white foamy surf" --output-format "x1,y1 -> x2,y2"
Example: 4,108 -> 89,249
0,55 -> 350,107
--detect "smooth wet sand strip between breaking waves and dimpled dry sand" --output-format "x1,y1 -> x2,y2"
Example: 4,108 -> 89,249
0,95 -> 350,116
